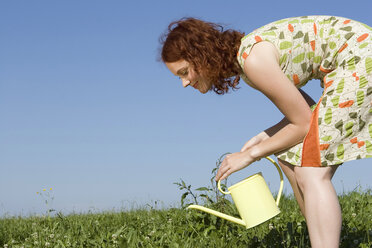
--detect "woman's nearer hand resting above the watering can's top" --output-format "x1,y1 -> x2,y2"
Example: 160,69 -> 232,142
215,150 -> 257,181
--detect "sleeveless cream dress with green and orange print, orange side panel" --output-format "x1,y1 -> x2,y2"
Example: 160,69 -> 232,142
237,16 -> 372,167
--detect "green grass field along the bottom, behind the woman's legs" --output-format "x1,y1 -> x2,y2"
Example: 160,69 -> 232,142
0,190 -> 372,248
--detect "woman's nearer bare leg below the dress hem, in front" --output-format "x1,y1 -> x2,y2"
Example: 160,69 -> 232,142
294,166 -> 342,248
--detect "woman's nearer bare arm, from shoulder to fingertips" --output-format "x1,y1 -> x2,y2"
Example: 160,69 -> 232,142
216,41 -> 311,180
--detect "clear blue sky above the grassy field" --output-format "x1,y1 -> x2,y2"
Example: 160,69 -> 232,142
0,0 -> 372,216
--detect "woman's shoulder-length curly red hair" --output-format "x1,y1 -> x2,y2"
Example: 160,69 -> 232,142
160,18 -> 244,95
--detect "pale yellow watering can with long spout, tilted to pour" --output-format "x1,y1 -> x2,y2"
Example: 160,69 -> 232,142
187,157 -> 283,229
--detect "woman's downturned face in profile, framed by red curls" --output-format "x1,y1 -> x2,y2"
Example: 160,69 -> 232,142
165,60 -> 212,94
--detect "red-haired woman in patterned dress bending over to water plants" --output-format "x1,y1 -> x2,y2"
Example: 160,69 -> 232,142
161,16 -> 372,248
